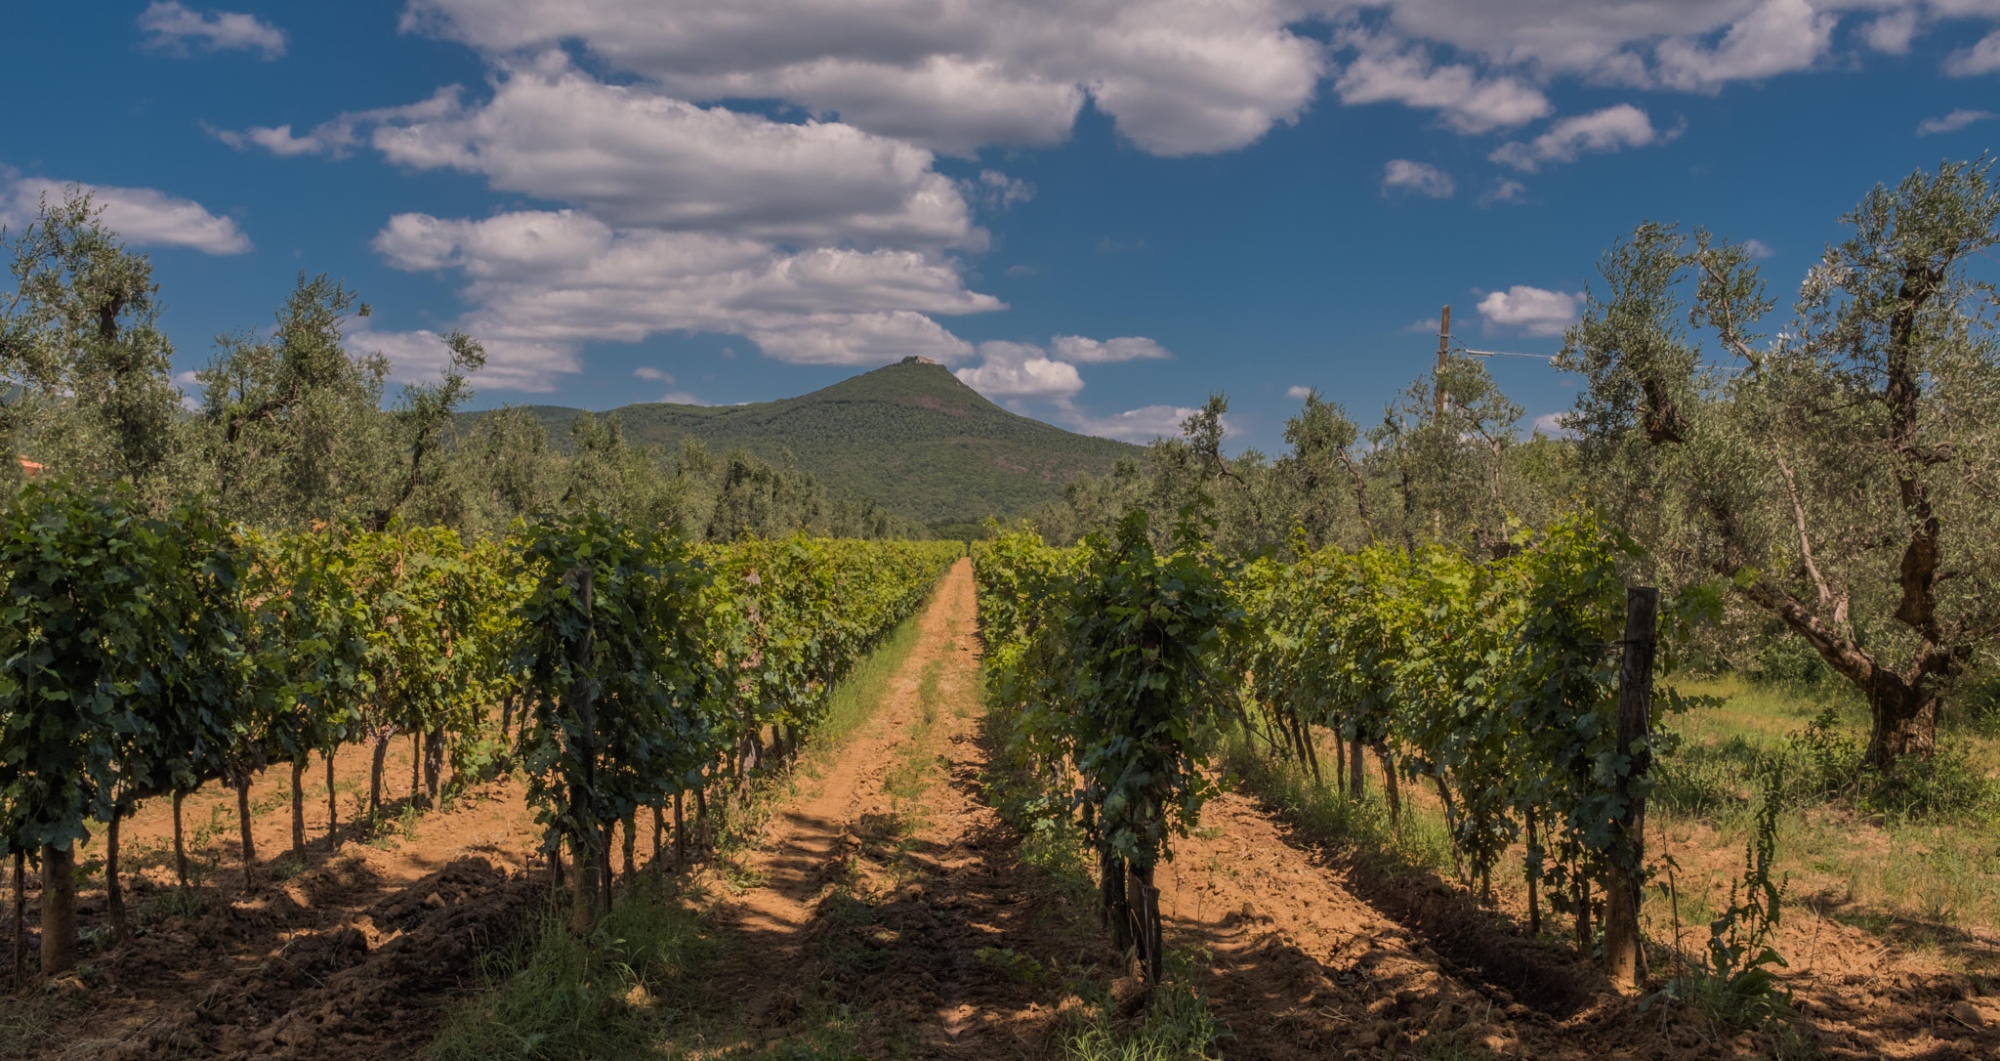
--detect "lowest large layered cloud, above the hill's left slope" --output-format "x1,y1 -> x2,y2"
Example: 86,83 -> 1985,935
374,210 -> 1004,390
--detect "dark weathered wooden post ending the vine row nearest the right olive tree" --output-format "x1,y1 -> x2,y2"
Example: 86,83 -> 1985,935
1604,587 -> 1660,987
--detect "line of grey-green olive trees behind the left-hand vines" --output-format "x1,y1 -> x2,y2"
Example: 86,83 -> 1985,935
0,190 -> 920,541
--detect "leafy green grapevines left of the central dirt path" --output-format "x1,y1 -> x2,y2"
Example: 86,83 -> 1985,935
0,482 -> 962,973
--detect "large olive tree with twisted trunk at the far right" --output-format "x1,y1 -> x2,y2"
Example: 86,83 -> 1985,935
1562,160 -> 2000,771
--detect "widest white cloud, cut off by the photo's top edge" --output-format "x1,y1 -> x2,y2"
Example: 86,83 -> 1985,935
402,0 -> 1324,154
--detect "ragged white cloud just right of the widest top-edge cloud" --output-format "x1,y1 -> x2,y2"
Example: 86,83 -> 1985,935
1334,32 -> 1554,132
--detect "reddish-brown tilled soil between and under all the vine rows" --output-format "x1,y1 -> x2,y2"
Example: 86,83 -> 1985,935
3,563 -> 2000,1061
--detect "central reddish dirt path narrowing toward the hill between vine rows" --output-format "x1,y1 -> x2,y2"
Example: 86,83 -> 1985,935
718,563 -> 1102,1059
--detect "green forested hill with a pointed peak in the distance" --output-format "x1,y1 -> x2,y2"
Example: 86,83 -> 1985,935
504,358 -> 1142,522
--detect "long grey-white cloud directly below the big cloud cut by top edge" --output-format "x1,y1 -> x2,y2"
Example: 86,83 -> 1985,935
230,62 -> 980,246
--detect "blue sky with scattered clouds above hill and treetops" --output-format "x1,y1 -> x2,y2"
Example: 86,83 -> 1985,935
0,0 -> 2000,452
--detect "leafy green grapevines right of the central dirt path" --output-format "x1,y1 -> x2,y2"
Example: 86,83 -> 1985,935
974,516 -> 1706,977
